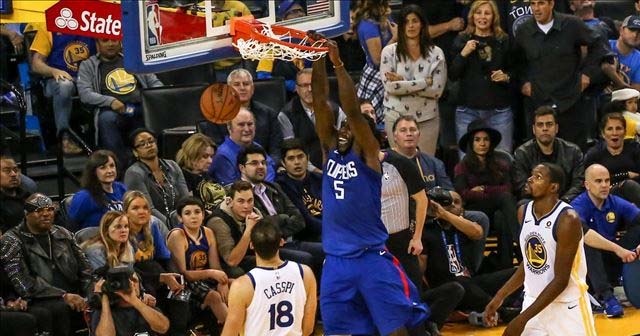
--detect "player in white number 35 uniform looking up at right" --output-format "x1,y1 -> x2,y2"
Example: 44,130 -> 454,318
484,163 -> 596,335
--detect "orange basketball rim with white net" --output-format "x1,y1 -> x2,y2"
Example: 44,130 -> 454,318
230,16 -> 329,61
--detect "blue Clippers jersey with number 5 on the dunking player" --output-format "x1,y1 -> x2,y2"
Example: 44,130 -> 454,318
322,149 -> 388,257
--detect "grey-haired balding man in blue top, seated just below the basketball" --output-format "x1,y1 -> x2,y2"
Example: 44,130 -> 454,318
209,107 -> 280,186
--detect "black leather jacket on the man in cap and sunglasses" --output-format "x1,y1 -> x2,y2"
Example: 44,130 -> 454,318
0,222 -> 92,299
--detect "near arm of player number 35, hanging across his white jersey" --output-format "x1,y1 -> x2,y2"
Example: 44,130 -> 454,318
504,209 -> 582,335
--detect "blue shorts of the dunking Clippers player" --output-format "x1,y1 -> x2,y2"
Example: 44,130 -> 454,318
320,249 -> 430,335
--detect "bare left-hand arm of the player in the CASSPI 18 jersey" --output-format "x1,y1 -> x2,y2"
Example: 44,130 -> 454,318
221,275 -> 253,336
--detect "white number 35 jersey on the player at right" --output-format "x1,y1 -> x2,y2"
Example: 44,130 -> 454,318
520,201 -> 587,302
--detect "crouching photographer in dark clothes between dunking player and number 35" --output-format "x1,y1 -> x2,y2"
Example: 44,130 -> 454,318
422,187 -> 515,324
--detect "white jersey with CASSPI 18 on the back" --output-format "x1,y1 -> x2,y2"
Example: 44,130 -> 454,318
244,261 -> 307,336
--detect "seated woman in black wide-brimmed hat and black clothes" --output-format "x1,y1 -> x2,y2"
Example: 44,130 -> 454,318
454,120 -> 519,268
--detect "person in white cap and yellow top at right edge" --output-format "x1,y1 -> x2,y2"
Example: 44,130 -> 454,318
603,88 -> 640,141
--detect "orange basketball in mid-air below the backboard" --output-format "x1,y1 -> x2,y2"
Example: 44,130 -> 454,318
200,83 -> 240,124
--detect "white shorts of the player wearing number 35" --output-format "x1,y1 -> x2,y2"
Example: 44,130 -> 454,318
522,294 -> 596,336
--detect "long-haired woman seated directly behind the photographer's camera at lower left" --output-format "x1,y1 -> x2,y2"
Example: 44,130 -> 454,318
81,211 -> 134,271
